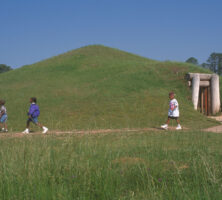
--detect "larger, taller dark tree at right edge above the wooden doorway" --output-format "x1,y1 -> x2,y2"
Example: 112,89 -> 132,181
207,53 -> 222,75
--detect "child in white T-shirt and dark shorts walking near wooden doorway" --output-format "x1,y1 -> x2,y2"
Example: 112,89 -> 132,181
161,92 -> 182,130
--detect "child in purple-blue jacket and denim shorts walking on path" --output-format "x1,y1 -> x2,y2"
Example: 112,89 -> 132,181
22,97 -> 48,134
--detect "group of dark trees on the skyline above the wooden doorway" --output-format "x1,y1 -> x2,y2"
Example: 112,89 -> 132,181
185,52 -> 222,75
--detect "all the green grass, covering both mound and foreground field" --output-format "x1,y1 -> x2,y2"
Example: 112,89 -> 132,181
0,45 -> 222,200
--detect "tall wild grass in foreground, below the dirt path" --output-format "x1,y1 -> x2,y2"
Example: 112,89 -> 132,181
0,131 -> 222,200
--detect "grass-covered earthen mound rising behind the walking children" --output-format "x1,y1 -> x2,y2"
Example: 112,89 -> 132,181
0,45 -> 219,131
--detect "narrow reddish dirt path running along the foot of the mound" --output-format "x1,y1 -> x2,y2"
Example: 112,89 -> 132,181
0,127 -> 187,138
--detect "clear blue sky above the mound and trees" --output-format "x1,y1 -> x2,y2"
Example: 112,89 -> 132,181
0,0 -> 222,67
